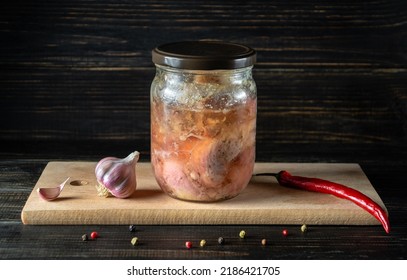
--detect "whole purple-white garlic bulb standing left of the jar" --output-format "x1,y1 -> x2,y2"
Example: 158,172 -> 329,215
95,151 -> 140,198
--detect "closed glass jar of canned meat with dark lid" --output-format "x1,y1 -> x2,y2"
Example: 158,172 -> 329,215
151,41 -> 257,202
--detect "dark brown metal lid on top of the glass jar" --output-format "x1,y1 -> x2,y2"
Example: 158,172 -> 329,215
152,41 -> 256,70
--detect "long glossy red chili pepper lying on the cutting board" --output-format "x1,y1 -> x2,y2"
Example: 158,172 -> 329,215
255,170 -> 390,233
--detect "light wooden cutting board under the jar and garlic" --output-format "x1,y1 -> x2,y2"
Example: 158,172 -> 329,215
21,162 -> 385,225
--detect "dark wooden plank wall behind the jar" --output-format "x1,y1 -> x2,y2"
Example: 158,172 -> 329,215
0,0 -> 407,161
